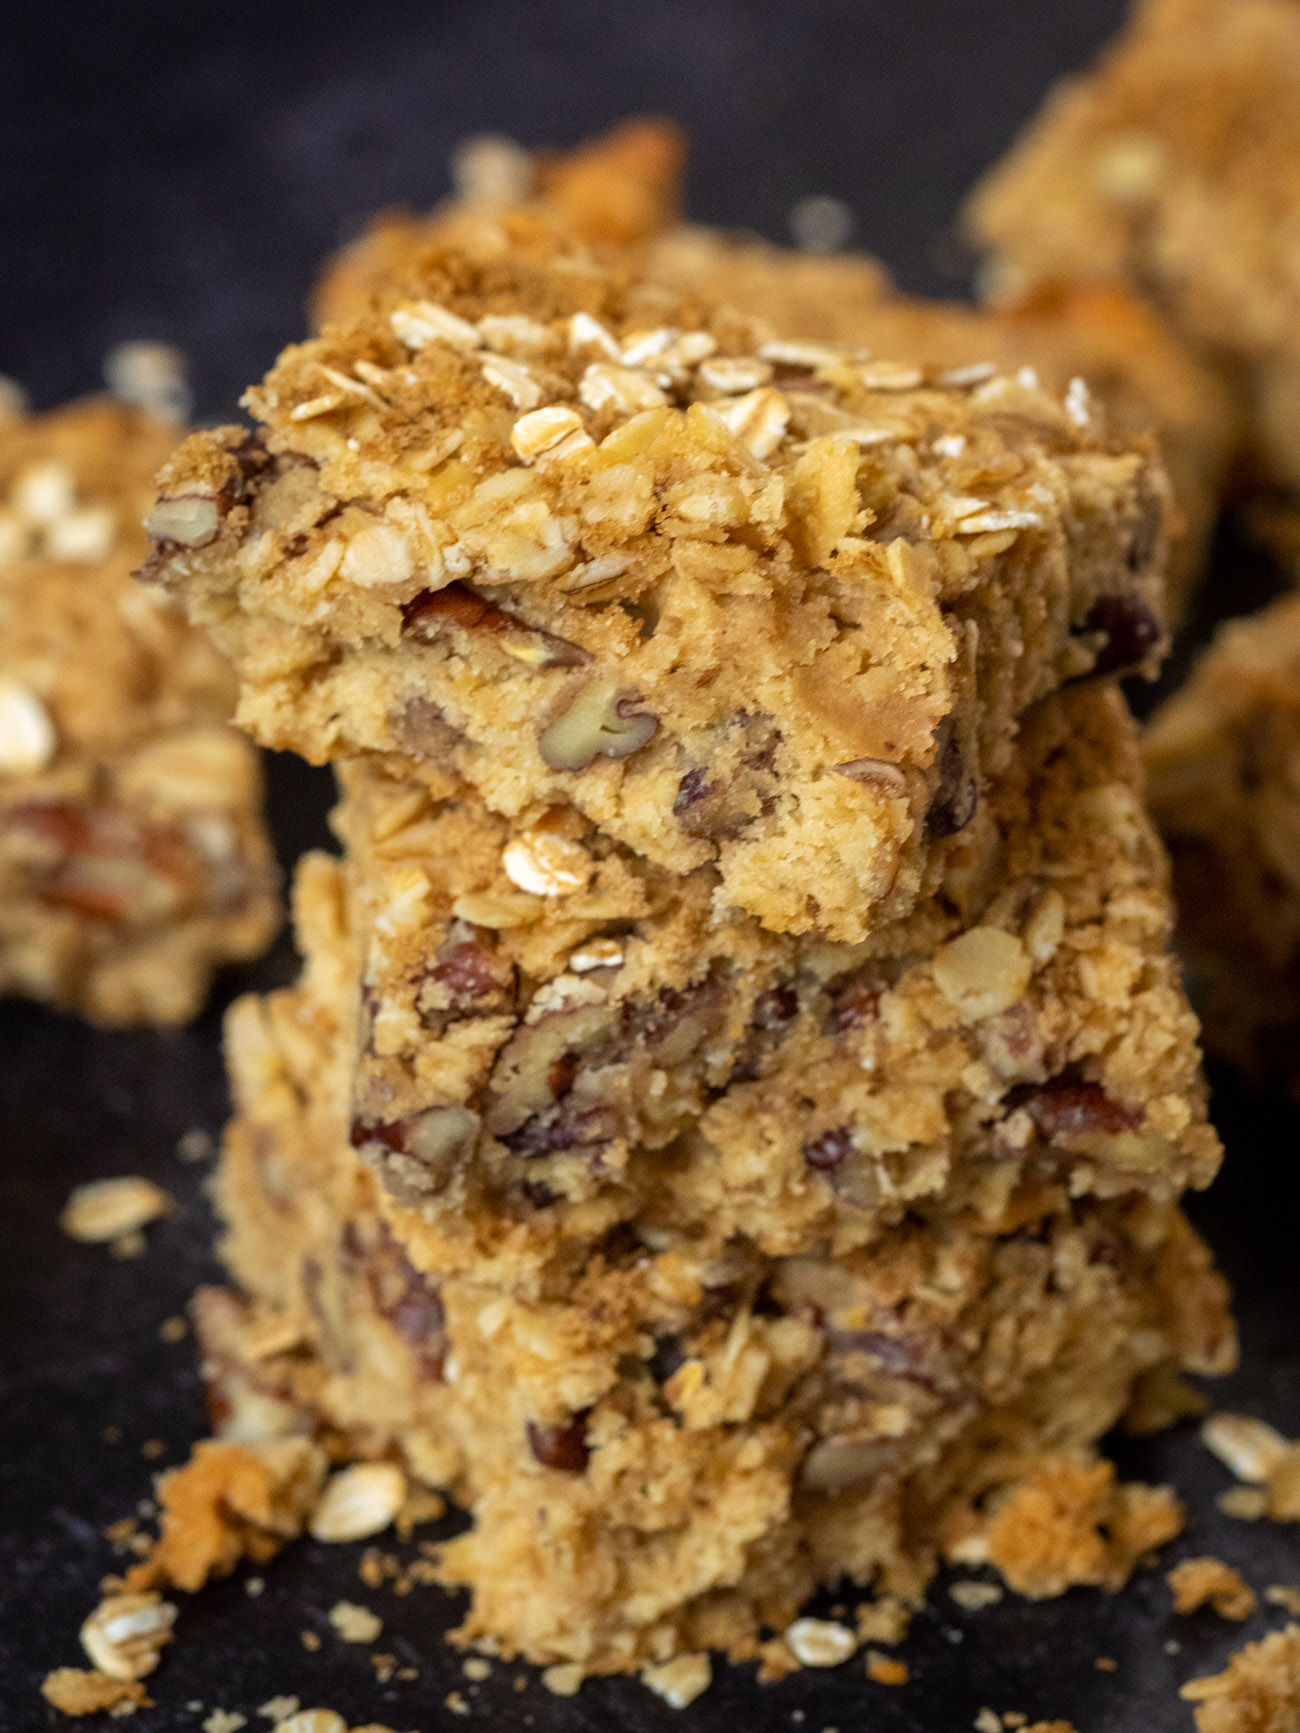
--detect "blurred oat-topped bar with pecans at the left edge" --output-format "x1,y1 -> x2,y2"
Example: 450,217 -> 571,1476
0,399 -> 277,1024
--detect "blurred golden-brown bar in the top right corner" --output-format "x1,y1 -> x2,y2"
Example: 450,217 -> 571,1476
967,0 -> 1300,502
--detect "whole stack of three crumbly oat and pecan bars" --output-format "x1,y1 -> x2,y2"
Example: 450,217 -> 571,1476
130,211 -> 1232,1702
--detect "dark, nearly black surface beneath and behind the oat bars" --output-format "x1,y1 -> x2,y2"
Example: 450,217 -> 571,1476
0,0 -> 1300,1733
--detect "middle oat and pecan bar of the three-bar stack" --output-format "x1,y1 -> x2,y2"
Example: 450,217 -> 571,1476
325,686 -> 1219,1281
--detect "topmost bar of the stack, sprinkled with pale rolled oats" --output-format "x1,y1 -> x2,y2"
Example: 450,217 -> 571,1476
146,235 -> 1168,941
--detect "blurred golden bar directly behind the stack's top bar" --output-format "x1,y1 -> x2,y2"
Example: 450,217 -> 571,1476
314,121 -> 1241,624
